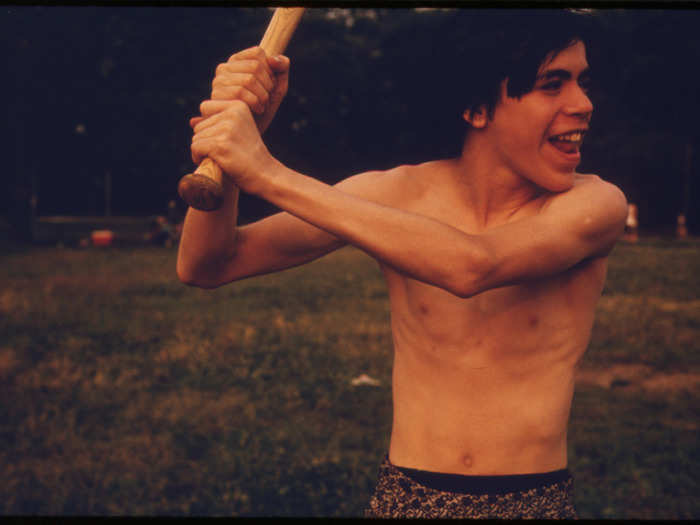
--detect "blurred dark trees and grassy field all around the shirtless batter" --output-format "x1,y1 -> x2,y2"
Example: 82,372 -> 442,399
0,2 -> 700,519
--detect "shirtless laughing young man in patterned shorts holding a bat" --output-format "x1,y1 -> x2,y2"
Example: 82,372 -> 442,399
177,10 -> 627,518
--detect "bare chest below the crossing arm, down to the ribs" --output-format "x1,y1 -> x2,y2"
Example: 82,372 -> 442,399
385,260 -> 605,364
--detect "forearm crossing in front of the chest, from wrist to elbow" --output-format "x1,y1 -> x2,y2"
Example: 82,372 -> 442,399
251,161 -> 486,296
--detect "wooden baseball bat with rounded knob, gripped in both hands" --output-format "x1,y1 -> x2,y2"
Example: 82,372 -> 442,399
177,7 -> 305,211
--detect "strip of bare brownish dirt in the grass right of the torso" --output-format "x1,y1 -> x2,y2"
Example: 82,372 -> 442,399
576,364 -> 700,392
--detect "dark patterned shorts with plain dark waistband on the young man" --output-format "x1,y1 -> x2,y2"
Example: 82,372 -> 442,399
365,456 -> 577,519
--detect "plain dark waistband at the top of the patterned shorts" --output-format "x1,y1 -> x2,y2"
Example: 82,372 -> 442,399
385,456 -> 572,494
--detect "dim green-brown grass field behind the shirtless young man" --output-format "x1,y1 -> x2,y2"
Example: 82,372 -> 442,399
0,240 -> 700,519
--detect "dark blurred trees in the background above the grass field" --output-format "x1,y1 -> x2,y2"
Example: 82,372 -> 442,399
0,6 -> 700,236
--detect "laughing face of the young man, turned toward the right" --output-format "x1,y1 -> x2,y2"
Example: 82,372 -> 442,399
471,41 -> 593,192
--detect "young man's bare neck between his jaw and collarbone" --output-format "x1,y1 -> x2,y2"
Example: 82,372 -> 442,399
454,133 -> 544,226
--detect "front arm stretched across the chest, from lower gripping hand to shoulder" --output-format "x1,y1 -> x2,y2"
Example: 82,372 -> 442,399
192,98 -> 626,297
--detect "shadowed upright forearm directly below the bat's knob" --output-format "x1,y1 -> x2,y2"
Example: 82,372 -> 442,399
177,177 -> 240,287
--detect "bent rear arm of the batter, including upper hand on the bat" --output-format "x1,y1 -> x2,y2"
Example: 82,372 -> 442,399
177,47 -> 330,288
